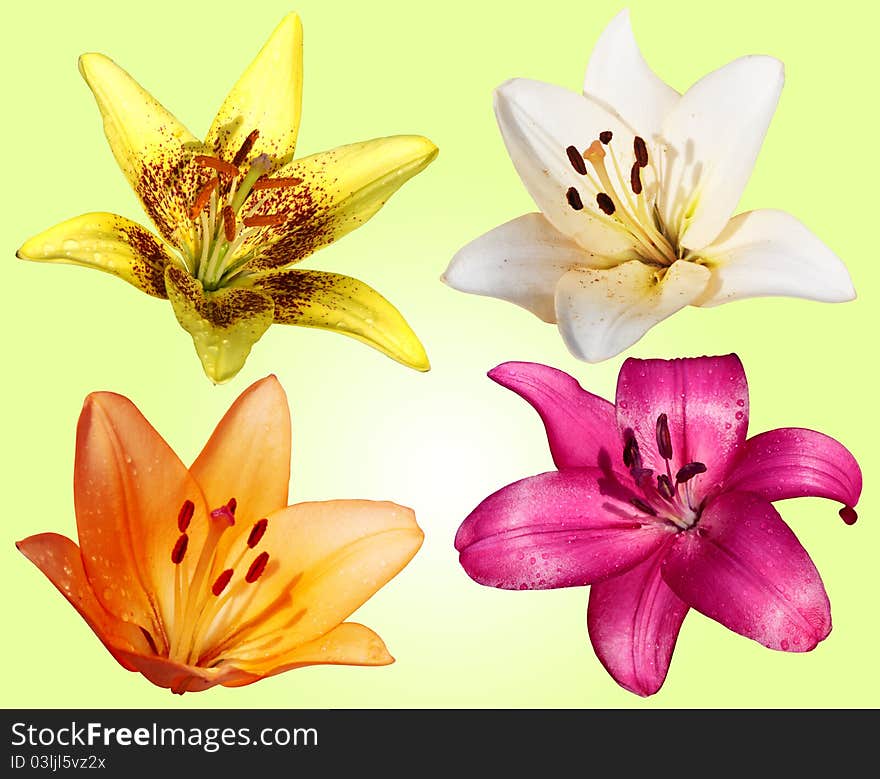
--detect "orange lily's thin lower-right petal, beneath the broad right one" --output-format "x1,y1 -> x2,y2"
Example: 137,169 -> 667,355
222,622 -> 394,687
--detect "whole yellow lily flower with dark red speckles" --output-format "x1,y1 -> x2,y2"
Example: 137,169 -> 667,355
17,14 -> 437,383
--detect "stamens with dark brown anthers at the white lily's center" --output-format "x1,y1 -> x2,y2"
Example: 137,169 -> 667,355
565,130 -> 682,267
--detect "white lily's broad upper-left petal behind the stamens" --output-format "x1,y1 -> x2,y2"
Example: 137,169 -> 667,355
495,79 -> 635,260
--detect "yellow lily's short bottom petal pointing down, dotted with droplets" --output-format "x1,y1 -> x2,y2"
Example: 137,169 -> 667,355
165,265 -> 273,384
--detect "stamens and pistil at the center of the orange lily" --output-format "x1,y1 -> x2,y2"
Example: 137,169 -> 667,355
168,498 -> 269,665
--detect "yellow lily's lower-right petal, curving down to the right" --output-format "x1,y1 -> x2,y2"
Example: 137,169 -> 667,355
247,270 -> 431,371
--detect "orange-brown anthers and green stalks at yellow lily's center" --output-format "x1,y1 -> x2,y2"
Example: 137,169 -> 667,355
175,130 -> 302,290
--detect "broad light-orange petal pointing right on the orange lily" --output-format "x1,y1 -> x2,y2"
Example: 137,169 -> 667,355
209,500 -> 424,659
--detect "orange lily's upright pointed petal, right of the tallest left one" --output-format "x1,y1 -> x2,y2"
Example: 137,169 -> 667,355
189,376 -> 290,528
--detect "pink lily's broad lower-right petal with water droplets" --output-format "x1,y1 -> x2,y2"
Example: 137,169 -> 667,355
662,492 -> 831,652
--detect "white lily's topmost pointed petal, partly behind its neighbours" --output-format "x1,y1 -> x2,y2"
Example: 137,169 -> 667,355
584,9 -> 679,140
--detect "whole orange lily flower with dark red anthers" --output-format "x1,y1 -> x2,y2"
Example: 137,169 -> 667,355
16,376 -> 423,693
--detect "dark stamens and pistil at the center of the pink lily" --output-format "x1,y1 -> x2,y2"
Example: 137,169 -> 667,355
623,414 -> 706,530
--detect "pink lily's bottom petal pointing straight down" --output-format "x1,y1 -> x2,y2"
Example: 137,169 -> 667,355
587,539 -> 688,696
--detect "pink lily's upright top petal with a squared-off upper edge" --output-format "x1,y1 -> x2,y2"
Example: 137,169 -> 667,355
617,354 -> 749,505
